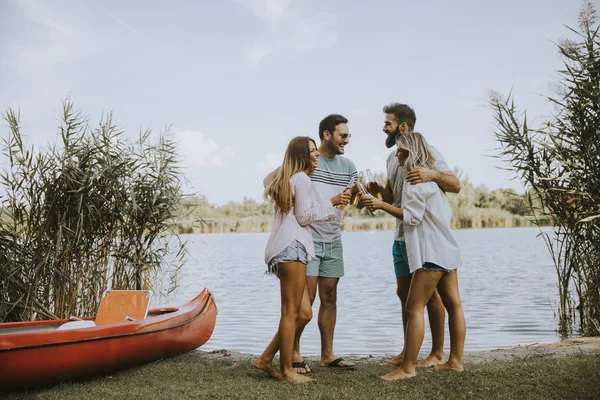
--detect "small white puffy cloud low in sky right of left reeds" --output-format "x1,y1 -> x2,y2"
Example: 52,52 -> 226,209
176,130 -> 234,168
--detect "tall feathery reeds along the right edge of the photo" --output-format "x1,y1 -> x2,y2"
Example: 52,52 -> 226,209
491,2 -> 600,335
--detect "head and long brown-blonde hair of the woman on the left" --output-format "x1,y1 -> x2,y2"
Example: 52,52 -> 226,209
265,136 -> 317,214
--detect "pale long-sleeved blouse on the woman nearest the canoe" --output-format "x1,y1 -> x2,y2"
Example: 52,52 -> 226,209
265,172 -> 336,264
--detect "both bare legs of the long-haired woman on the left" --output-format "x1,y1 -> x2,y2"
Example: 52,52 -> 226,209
254,261 -> 312,383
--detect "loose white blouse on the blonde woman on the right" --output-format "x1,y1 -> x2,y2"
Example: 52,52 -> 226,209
402,182 -> 460,272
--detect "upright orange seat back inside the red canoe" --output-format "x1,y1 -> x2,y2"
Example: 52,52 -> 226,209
95,290 -> 152,326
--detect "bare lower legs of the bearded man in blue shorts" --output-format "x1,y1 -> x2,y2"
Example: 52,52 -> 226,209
384,275 -> 446,368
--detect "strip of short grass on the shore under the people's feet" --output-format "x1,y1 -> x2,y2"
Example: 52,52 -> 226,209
5,352 -> 600,400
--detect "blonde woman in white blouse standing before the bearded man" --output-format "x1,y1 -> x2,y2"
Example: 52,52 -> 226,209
363,132 -> 467,380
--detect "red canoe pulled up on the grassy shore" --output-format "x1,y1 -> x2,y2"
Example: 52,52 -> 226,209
0,289 -> 217,391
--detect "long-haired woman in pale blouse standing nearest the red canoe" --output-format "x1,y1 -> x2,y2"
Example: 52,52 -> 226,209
254,136 -> 335,383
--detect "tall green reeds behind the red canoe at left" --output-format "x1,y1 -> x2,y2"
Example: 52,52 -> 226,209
0,100 -> 186,321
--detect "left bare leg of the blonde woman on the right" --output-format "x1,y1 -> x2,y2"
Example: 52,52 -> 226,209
381,269 -> 444,380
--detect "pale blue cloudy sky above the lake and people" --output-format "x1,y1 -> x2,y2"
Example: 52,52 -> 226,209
0,0 -> 582,204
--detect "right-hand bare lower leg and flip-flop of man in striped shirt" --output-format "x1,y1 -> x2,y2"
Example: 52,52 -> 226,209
317,277 -> 355,368
